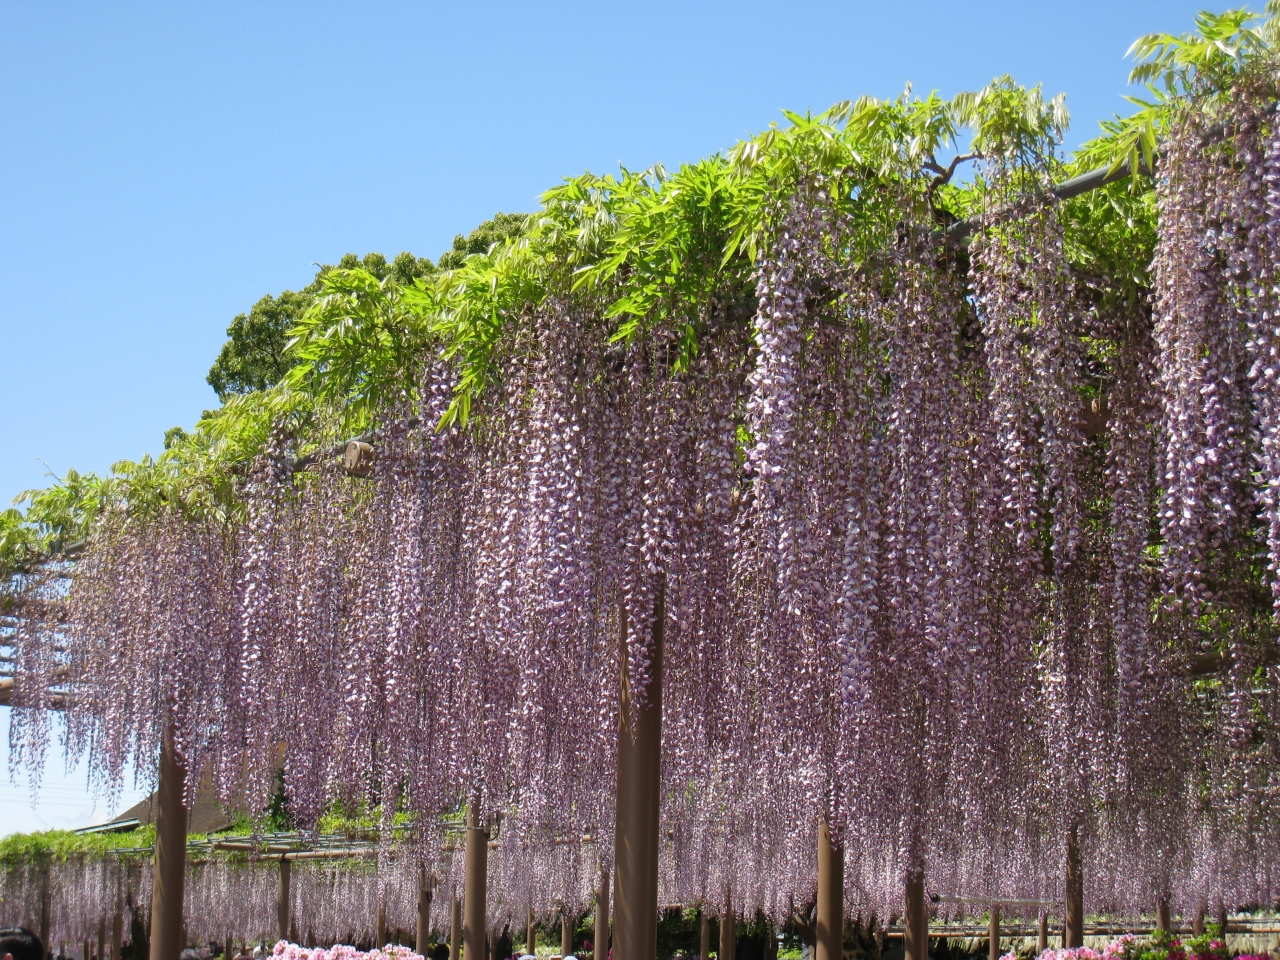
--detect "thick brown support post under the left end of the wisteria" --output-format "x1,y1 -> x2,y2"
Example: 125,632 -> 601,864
150,727 -> 187,960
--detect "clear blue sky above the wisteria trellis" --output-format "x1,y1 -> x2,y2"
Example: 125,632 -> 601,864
0,0 -> 1242,833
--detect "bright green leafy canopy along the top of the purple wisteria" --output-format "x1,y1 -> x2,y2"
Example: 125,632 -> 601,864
0,0 -> 1280,586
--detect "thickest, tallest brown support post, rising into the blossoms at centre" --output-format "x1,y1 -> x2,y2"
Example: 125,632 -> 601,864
613,579 -> 667,960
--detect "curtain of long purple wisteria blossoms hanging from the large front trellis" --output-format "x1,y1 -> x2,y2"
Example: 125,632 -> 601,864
7,82 -> 1280,942
